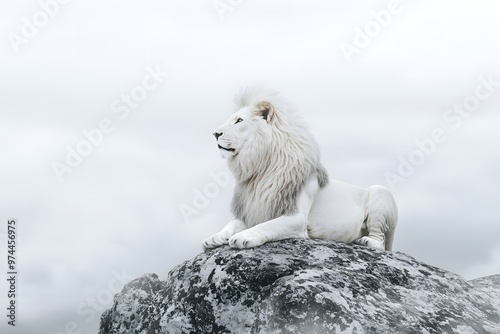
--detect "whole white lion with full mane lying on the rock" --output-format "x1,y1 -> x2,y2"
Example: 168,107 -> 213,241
203,89 -> 397,250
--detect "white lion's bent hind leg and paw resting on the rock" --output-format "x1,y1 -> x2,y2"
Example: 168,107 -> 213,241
354,185 -> 398,250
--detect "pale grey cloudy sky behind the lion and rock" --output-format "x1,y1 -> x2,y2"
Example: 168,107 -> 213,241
0,0 -> 500,334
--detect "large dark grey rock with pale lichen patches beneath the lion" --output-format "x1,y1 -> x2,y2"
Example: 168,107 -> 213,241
99,240 -> 500,334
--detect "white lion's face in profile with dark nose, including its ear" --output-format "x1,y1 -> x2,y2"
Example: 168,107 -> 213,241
213,102 -> 273,159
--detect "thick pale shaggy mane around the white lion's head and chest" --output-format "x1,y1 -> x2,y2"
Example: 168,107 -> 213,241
228,88 -> 328,227
